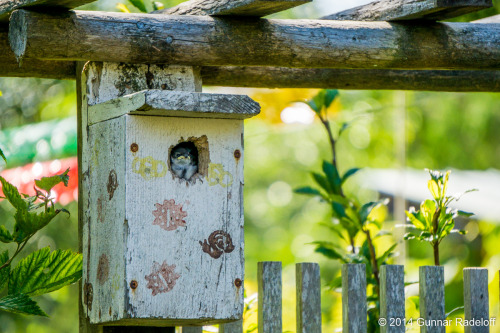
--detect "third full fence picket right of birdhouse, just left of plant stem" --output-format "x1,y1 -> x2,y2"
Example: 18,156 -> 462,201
342,264 -> 367,333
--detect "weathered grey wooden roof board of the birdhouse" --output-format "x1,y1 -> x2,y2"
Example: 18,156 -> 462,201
89,90 -> 260,125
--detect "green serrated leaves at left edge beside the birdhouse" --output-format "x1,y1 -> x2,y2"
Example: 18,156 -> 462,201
0,169 -> 82,316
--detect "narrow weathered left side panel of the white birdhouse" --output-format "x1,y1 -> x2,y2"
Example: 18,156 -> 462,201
83,117 -> 126,323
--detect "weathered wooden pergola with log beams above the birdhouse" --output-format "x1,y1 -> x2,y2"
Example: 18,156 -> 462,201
0,0 -> 500,333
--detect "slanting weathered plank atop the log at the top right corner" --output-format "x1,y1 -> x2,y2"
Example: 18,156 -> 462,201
322,0 -> 493,21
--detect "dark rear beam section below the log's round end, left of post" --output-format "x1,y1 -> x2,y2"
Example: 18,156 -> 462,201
0,27 -> 76,80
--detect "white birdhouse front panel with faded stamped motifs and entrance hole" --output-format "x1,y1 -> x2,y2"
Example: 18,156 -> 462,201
124,115 -> 243,323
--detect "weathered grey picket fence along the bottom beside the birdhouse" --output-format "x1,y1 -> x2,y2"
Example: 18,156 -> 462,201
178,261 -> 490,333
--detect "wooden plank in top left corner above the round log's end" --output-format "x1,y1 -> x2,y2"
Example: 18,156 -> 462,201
0,0 -> 96,24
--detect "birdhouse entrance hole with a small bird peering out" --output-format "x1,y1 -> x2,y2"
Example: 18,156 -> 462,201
168,135 -> 210,183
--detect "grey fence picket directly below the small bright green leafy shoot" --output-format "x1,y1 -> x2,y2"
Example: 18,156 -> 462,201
419,266 -> 446,333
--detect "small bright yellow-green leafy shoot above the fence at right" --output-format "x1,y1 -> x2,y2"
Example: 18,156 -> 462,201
404,170 -> 474,265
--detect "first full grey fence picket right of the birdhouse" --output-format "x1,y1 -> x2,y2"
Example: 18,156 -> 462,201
257,261 -> 282,333
